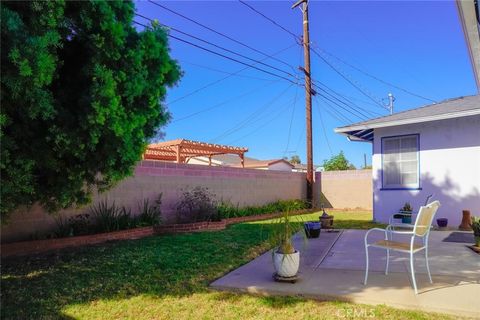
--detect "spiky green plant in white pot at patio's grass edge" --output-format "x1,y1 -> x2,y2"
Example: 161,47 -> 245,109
270,210 -> 302,279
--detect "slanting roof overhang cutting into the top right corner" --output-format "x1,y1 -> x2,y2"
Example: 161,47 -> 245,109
456,0 -> 480,93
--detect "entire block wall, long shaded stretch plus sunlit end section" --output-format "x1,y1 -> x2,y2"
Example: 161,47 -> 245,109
1,161 -> 372,242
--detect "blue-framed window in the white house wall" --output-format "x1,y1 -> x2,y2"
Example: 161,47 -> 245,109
382,135 -> 420,189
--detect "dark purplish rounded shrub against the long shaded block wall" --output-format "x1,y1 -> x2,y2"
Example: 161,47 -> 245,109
176,186 -> 219,223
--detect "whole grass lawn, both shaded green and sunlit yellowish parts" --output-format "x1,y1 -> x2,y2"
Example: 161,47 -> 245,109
1,212 -> 456,320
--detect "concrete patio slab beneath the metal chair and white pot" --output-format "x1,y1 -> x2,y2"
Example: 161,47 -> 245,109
211,230 -> 480,319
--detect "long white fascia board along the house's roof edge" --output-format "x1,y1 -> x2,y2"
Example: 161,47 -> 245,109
335,108 -> 480,133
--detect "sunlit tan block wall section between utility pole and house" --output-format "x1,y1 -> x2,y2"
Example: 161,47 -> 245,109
316,170 -> 373,210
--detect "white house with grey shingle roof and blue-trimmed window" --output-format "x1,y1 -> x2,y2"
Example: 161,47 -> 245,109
335,95 -> 480,227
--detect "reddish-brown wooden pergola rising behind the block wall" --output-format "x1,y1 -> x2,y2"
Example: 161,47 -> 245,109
143,139 -> 248,167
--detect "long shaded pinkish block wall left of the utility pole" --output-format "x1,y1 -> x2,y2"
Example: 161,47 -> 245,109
1,161 -> 306,242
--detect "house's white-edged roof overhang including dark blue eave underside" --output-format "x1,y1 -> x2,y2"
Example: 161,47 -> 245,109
335,109 -> 480,142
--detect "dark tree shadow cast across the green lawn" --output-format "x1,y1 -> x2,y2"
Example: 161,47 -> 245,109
1,216 -> 380,319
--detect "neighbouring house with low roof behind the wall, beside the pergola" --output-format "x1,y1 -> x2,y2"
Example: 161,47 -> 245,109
188,154 -> 293,171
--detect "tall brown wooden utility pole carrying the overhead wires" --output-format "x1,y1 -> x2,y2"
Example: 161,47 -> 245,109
292,0 -> 313,206
